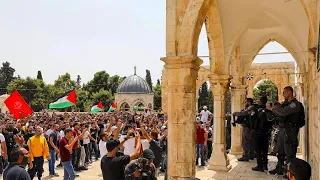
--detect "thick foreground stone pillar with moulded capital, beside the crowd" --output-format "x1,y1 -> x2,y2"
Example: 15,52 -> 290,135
162,56 -> 202,180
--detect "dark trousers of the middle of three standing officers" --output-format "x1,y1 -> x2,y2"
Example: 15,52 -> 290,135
256,133 -> 269,168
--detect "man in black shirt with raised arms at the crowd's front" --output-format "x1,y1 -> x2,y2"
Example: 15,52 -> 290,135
100,131 -> 141,180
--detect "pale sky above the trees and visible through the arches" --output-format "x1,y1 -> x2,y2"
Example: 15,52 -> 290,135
0,0 -> 293,83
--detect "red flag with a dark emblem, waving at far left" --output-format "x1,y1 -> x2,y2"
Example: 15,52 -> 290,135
4,90 -> 33,119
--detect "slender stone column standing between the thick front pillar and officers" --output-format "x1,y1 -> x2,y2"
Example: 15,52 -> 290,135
208,75 -> 230,171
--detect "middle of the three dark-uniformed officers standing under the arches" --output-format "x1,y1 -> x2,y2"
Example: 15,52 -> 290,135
251,96 -> 272,172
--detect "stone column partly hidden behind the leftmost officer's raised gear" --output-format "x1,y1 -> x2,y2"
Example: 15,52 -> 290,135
230,85 -> 247,155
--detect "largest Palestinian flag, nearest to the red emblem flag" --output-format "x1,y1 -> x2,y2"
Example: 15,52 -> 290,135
49,90 -> 77,109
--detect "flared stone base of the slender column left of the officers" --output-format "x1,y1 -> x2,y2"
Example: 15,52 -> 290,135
208,143 -> 231,172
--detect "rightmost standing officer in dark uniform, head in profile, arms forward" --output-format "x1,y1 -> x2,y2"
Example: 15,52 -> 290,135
267,86 -> 303,172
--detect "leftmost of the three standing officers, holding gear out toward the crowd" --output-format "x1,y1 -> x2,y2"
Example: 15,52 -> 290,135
233,98 -> 254,161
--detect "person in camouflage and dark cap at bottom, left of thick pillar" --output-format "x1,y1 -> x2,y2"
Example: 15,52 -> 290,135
124,149 -> 157,180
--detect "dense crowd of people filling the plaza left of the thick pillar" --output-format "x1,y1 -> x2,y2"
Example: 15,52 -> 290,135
0,109 -> 168,180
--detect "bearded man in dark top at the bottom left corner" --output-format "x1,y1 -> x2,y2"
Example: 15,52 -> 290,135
3,147 -> 31,180
